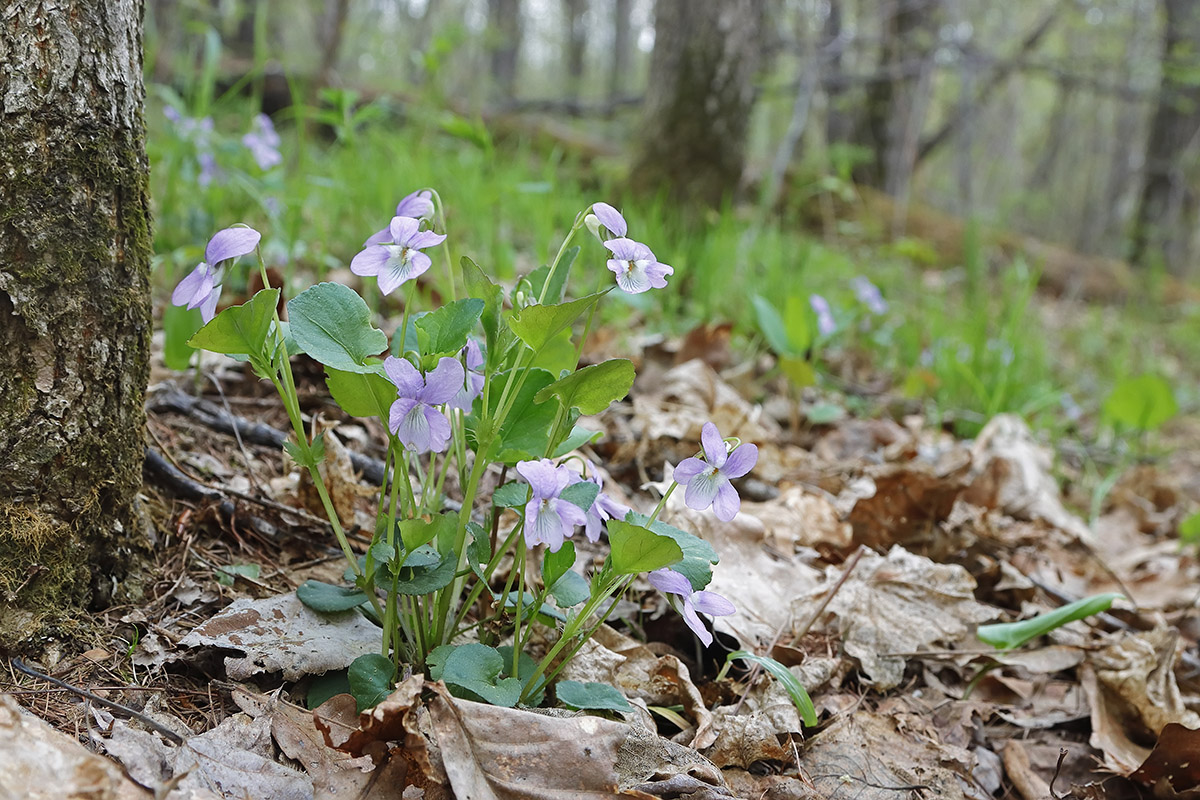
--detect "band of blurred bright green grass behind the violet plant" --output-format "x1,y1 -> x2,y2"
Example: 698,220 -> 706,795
148,92 -> 1200,448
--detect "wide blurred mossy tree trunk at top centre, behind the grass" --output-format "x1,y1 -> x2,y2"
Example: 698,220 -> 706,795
631,0 -> 768,206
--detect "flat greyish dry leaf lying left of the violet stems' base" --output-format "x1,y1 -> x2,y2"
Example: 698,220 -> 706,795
179,593 -> 379,680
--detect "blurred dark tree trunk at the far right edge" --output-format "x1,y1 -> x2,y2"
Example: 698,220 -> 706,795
1130,0 -> 1200,275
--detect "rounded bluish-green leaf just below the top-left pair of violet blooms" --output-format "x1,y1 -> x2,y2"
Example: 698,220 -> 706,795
288,283 -> 388,372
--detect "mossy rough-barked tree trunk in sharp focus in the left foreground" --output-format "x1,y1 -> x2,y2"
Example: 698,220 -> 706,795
0,0 -> 151,651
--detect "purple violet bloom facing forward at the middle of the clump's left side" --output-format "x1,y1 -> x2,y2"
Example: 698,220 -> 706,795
383,355 -> 463,455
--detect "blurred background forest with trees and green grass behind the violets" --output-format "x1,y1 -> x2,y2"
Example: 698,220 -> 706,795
145,0 -> 1200,441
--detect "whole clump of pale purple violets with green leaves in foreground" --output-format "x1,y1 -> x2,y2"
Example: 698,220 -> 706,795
172,196 -> 757,708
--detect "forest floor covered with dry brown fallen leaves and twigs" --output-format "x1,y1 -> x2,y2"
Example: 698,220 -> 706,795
0,292 -> 1200,800
